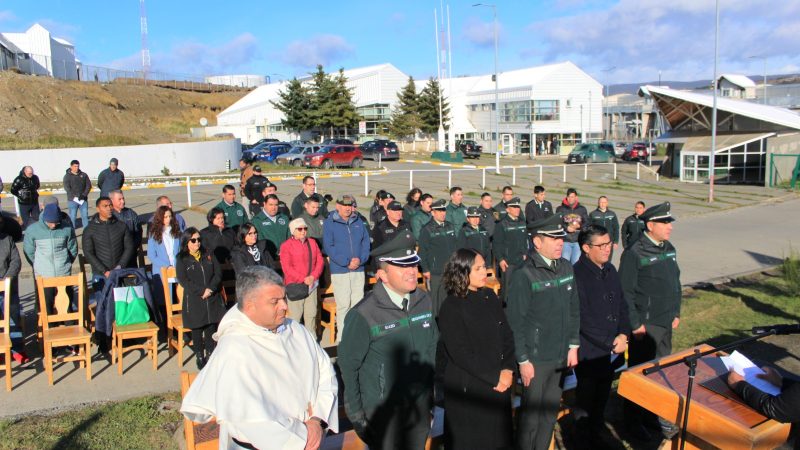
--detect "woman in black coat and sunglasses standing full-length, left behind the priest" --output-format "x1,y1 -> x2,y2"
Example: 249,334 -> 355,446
175,227 -> 225,369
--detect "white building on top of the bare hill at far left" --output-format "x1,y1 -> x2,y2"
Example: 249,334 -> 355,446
0,23 -> 80,80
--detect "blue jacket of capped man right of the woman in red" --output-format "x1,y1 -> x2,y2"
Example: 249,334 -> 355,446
322,211 -> 369,274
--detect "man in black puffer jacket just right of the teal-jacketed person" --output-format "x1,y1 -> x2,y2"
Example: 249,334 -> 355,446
81,197 -> 136,292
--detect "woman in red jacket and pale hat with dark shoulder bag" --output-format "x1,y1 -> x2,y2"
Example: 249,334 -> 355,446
280,219 -> 324,336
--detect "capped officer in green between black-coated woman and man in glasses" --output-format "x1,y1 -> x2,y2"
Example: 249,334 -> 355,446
506,214 -> 580,450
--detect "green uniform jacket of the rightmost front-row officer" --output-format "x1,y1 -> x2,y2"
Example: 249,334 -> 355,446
619,235 -> 682,330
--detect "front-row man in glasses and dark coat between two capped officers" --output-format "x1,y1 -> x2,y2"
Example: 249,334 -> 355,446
573,224 -> 631,446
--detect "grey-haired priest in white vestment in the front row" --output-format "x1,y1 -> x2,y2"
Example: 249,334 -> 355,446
181,266 -> 339,450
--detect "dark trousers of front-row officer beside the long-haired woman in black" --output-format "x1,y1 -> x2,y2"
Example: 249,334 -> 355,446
517,361 -> 567,450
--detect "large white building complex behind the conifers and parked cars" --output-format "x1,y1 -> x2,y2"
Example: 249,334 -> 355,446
205,62 -> 603,153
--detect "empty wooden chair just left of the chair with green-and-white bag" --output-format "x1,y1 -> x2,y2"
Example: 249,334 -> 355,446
36,274 -> 92,386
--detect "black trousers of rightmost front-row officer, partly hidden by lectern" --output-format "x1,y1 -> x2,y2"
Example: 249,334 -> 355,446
625,324 -> 672,426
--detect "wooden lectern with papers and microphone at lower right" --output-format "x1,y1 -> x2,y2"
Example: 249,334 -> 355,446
617,344 -> 790,450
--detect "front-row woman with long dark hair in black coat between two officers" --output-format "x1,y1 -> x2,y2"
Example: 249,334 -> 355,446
437,248 -> 516,450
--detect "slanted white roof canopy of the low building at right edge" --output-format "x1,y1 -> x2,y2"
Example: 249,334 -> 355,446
640,85 -> 800,132
